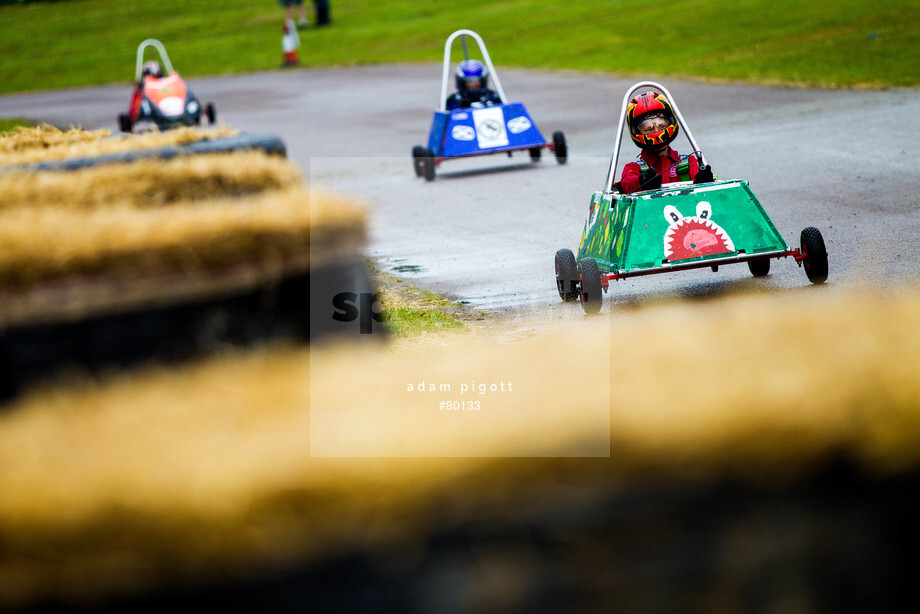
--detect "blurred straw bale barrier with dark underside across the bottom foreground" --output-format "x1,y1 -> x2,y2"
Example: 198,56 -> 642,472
0,286 -> 920,612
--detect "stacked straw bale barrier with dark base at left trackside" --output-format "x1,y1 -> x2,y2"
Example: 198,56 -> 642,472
0,127 -> 364,396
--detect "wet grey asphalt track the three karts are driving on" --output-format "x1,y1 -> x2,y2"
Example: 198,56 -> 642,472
0,64 -> 920,317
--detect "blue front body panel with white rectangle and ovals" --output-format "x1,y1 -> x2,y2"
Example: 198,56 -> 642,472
428,102 -> 546,158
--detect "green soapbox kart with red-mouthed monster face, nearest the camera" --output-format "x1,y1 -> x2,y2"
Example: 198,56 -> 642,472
555,81 -> 828,313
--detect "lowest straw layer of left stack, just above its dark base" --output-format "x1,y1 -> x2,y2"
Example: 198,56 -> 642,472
0,177 -> 364,325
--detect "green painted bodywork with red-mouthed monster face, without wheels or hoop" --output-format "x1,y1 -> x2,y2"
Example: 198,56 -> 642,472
578,181 -> 788,273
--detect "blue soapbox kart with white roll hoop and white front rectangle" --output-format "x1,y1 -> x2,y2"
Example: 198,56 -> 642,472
412,30 -> 568,181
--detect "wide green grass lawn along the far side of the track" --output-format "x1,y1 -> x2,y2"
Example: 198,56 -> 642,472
0,0 -> 920,93
